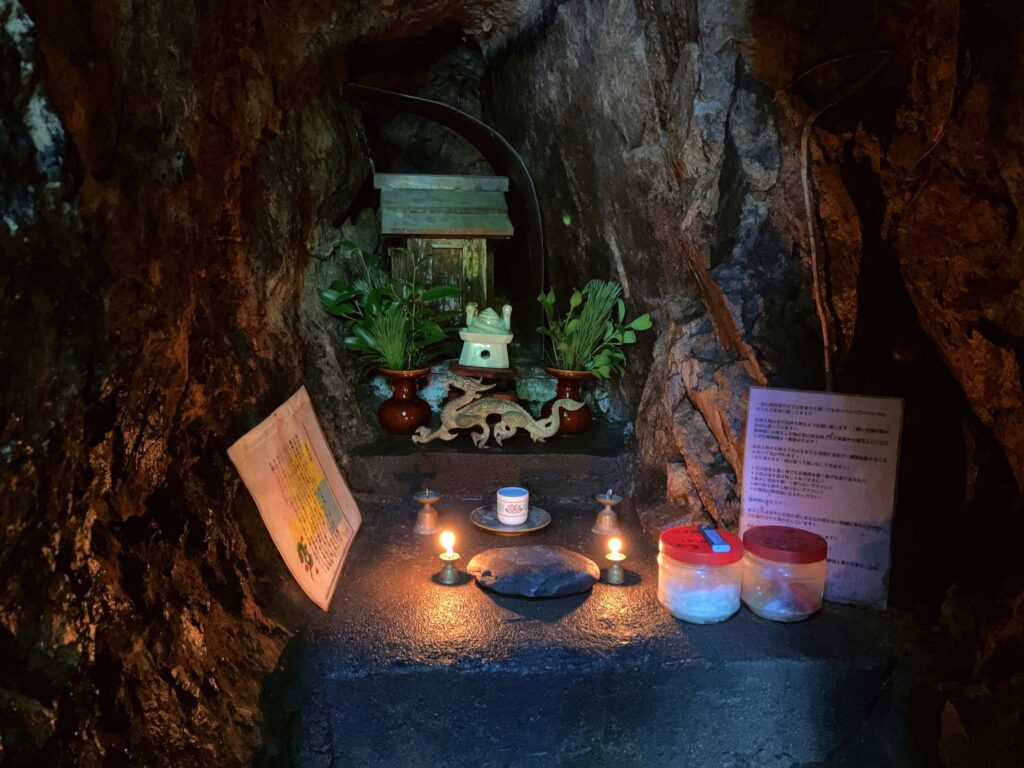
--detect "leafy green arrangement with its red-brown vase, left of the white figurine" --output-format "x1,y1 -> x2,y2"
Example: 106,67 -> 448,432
319,242 -> 460,435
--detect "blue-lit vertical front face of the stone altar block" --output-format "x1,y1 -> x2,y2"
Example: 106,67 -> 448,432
257,660 -> 917,768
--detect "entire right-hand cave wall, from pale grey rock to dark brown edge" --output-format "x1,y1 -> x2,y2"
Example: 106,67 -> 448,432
485,0 -> 1024,765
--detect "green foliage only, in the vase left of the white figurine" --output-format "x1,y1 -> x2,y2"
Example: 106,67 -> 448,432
319,242 -> 460,371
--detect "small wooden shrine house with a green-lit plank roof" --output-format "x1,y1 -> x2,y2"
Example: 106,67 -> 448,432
374,173 -> 513,310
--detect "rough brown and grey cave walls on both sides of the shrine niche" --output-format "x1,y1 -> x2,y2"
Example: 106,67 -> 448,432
0,0 -> 1024,765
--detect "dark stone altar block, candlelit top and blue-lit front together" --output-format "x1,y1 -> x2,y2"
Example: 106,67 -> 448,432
256,502 -> 941,768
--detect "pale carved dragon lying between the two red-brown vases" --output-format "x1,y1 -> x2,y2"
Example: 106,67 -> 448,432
413,372 -> 583,447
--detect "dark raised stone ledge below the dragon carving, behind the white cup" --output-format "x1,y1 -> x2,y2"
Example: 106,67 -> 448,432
345,421 -> 631,506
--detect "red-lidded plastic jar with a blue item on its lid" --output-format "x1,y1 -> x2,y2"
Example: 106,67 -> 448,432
657,525 -> 743,624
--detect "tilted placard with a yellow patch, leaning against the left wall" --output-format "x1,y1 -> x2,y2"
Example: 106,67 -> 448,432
227,387 -> 362,610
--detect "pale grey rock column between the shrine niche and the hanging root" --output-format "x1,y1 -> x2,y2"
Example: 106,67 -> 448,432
487,0 -> 820,528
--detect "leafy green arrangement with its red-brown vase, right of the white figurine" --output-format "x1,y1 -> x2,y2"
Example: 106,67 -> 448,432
537,280 -> 653,434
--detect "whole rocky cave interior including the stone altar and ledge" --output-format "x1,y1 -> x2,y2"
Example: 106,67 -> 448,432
0,0 -> 1024,768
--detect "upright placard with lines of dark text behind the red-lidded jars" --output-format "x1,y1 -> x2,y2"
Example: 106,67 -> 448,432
739,387 -> 903,610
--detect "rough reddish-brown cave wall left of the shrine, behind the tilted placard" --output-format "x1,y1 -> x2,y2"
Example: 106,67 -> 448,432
0,0 -> 378,765
